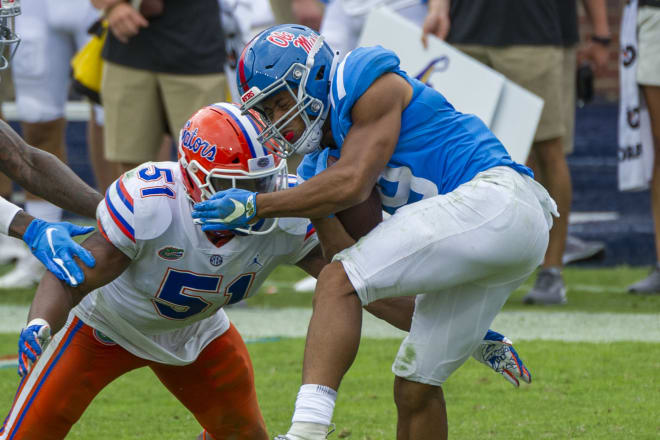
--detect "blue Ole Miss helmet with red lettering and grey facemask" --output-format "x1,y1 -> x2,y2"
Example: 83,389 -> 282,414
236,24 -> 338,158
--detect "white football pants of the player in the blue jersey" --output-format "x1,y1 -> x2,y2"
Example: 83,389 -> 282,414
335,167 -> 556,385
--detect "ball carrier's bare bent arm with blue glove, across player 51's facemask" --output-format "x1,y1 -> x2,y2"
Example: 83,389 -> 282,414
193,73 -> 412,225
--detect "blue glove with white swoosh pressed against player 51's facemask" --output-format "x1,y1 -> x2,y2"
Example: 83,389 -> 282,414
192,188 -> 257,231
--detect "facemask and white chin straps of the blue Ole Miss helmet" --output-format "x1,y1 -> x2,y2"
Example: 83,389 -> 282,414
241,36 -> 337,159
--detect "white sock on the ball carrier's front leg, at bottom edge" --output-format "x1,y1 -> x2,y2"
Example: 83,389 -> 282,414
287,384 -> 337,439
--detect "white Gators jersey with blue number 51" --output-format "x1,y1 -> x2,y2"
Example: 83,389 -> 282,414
73,162 -> 318,365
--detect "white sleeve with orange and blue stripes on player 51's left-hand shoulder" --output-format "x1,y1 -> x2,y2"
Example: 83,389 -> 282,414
96,167 -> 172,259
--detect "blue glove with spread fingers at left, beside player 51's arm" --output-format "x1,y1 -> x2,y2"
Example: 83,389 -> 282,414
23,219 -> 96,287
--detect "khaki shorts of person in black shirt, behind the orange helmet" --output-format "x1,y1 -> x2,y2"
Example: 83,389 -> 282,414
101,61 -> 227,164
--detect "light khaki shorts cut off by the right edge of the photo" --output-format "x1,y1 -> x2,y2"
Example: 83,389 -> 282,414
637,6 -> 660,86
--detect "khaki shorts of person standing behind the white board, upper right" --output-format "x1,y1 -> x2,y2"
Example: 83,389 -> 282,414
455,44 -> 565,142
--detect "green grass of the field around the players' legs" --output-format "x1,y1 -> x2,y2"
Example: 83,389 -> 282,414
0,267 -> 660,440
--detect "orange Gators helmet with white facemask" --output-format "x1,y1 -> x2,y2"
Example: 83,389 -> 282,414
179,102 -> 288,234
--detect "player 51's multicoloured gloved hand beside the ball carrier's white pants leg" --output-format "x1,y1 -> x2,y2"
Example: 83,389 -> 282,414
472,330 -> 532,388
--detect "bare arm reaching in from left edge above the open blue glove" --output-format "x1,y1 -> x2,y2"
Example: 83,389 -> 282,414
0,121 -> 103,218
